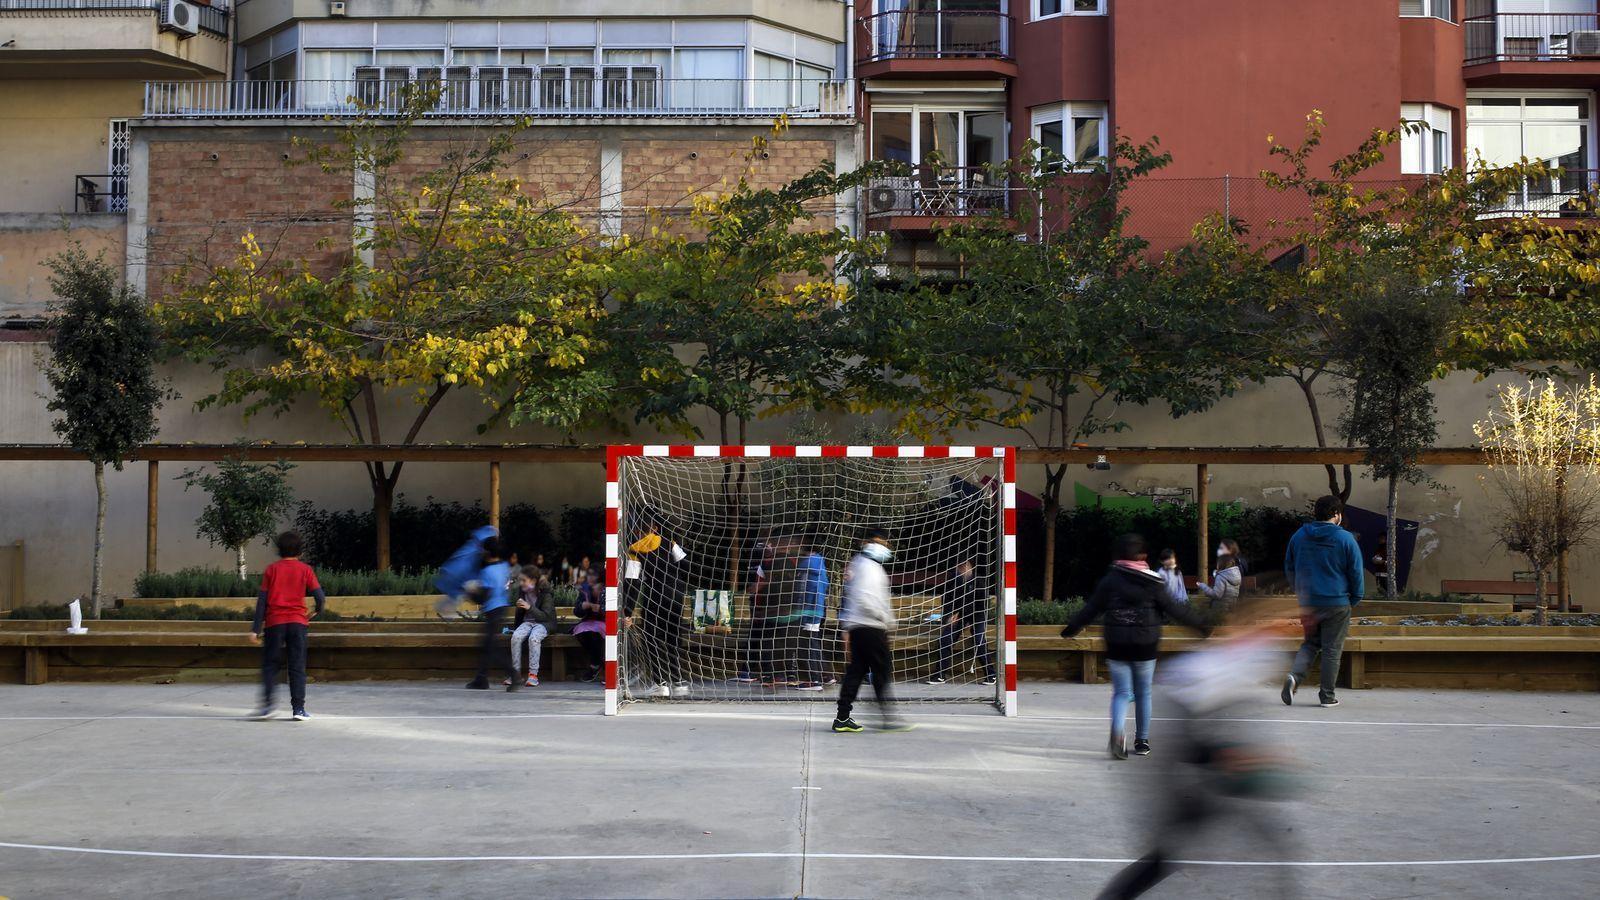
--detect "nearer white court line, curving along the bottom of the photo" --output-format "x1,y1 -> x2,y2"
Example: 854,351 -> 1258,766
0,841 -> 1600,868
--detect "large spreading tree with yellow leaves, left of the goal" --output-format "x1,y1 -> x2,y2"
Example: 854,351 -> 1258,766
157,88 -> 611,569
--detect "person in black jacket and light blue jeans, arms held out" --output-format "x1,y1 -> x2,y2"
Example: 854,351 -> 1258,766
1061,535 -> 1210,759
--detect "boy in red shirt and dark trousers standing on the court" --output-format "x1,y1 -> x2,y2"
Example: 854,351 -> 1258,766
250,532 -> 328,722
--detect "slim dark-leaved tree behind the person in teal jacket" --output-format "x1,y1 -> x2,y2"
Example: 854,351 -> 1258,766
1336,259 -> 1456,597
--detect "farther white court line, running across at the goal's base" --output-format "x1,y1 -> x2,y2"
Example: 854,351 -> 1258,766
0,701 -> 1600,732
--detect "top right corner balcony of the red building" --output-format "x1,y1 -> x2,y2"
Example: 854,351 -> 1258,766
1461,13 -> 1600,88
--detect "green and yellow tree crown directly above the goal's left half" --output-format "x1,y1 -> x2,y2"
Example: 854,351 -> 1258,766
606,139 -> 877,444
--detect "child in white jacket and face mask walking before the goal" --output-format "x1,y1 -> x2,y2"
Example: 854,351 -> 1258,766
834,528 -> 910,733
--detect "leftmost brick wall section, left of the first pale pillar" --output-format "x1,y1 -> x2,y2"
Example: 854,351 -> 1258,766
146,139 -> 352,296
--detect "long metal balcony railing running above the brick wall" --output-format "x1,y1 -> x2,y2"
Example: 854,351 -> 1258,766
144,75 -> 854,119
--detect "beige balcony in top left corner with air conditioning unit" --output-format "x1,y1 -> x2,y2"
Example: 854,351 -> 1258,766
0,0 -> 230,78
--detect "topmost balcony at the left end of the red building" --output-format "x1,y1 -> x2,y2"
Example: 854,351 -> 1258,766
856,10 -> 1018,78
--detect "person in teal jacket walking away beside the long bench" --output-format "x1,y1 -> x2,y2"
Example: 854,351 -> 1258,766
1280,495 -> 1366,708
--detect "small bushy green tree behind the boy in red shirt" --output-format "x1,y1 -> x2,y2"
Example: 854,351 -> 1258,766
178,456 -> 294,581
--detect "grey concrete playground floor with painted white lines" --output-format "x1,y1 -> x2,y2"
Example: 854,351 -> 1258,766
0,682 -> 1600,900
